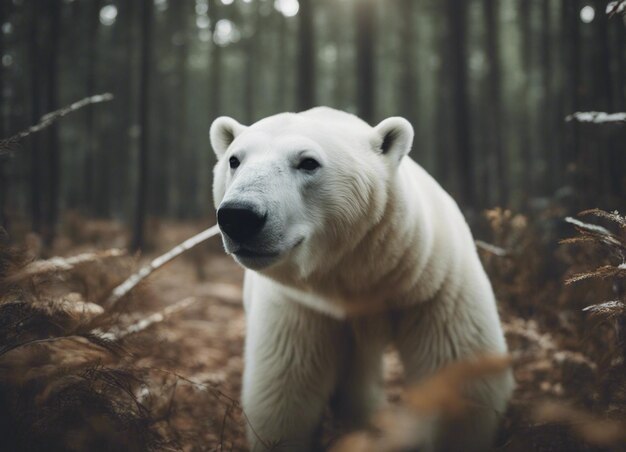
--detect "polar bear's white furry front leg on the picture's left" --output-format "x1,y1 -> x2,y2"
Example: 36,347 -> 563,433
242,291 -> 345,451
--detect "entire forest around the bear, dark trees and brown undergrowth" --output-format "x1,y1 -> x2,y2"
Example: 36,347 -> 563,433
0,0 -> 626,452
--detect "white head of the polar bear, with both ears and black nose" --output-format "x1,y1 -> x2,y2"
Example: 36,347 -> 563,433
211,107 -> 413,278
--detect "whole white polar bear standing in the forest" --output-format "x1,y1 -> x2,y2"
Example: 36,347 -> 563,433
211,107 -> 513,451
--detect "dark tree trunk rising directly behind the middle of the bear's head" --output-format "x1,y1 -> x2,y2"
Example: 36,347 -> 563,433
297,0 -> 316,111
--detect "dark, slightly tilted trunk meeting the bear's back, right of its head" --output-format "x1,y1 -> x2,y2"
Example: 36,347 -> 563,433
445,0 -> 476,208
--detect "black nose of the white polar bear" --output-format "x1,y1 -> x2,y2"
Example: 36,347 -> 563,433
217,202 -> 267,242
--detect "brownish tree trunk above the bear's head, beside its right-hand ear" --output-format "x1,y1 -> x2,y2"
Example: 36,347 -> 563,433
355,0 -> 376,123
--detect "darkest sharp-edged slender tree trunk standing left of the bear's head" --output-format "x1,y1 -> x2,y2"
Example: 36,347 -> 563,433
131,0 -> 154,250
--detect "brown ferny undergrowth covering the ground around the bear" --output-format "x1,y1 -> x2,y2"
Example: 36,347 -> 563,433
0,209 -> 626,451
